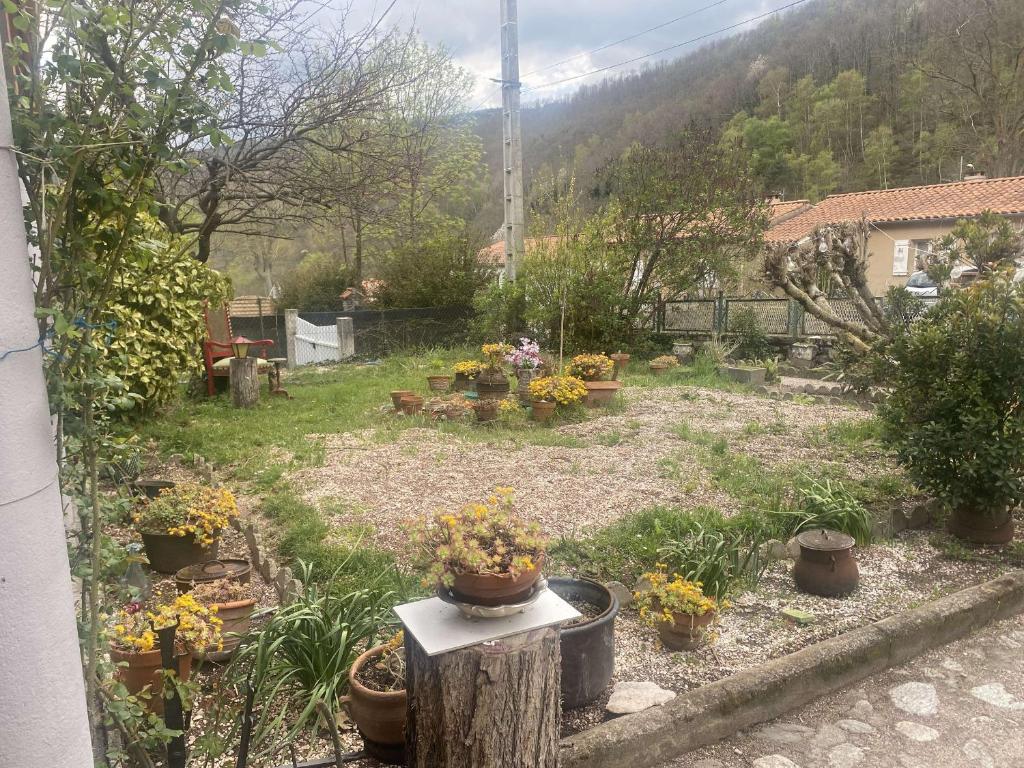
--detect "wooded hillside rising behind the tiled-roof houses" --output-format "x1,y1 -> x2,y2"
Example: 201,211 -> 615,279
477,0 -> 1024,230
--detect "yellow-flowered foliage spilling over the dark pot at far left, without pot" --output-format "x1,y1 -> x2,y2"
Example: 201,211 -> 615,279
132,482 -> 239,547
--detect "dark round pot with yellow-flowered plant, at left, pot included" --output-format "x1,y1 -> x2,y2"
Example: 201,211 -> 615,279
132,482 -> 239,573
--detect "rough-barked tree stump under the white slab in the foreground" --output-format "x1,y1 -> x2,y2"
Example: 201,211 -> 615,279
406,627 -> 561,768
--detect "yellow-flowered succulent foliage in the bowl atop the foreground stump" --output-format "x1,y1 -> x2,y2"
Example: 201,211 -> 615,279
413,487 -> 548,587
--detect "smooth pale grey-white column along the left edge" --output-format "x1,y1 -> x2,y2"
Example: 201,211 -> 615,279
0,50 -> 92,768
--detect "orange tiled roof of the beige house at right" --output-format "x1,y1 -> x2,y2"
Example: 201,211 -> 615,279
765,176 -> 1024,243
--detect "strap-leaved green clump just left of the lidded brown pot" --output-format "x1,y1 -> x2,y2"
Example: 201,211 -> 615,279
657,522 -> 768,601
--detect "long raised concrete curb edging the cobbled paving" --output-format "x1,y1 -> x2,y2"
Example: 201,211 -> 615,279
559,570 -> 1024,768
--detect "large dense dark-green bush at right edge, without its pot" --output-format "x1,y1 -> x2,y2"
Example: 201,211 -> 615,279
882,273 -> 1024,513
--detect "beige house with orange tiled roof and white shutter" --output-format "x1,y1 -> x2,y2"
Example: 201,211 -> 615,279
765,175 -> 1024,296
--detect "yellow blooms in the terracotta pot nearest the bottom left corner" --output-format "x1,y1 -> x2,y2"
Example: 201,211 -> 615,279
108,593 -> 223,653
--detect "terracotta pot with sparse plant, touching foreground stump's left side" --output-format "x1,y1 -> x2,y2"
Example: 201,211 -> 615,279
340,631 -> 408,765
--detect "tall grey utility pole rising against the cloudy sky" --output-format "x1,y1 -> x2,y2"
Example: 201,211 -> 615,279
501,0 -> 525,281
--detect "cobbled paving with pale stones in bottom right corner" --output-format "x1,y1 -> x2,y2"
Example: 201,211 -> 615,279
663,616 -> 1024,768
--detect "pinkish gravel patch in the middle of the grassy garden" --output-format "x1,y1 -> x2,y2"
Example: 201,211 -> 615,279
290,387 -> 889,557
